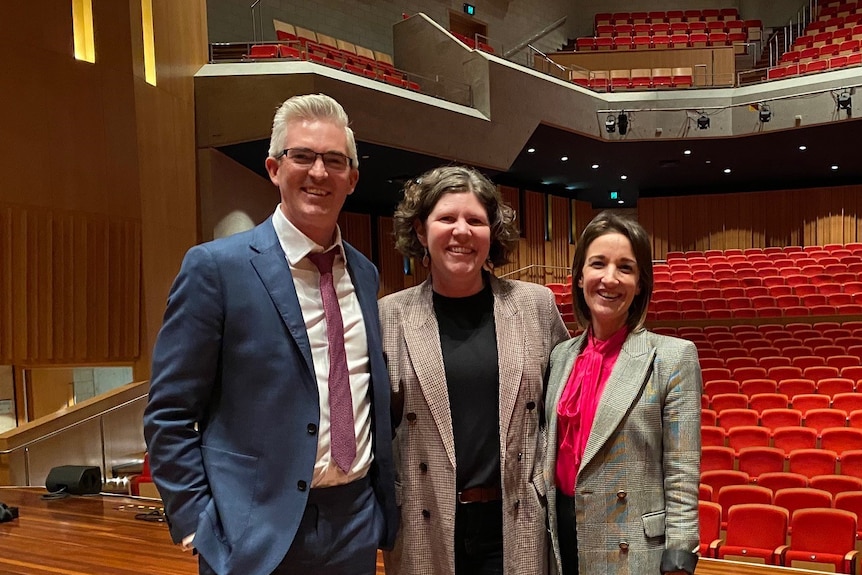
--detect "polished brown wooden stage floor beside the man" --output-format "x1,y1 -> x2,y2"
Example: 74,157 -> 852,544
0,487 -> 383,575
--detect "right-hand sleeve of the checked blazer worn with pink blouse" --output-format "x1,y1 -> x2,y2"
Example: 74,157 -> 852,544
661,342 -> 702,573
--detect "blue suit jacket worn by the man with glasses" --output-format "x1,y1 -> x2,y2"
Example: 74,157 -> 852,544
144,219 -> 398,575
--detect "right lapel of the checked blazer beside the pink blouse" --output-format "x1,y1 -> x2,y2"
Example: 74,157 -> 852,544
578,330 -> 655,472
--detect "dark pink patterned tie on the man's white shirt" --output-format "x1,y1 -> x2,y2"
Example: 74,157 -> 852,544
308,249 -> 356,473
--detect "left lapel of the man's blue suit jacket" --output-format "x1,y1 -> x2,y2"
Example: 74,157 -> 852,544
250,218 -> 314,377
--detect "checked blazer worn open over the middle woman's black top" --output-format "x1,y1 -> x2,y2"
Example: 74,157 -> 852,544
380,276 -> 569,575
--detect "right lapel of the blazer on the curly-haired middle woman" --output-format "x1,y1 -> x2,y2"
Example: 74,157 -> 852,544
489,275 -> 525,444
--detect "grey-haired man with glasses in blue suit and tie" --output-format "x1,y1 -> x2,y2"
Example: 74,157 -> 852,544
144,94 -> 398,575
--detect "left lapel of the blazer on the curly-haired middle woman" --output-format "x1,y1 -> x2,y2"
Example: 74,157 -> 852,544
404,278 -> 455,467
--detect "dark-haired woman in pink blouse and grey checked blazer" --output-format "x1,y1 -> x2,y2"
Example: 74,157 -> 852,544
545,212 -> 701,575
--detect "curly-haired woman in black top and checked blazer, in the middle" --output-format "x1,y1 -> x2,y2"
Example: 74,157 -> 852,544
380,166 -> 568,575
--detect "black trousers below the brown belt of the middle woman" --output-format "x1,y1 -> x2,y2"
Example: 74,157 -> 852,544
455,501 -> 503,575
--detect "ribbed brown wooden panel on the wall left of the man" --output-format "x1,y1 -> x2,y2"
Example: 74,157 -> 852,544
0,206 -> 141,365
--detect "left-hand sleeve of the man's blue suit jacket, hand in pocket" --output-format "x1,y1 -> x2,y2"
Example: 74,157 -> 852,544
144,245 -> 224,543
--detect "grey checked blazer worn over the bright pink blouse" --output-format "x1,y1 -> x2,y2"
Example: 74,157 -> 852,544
545,330 -> 702,575
